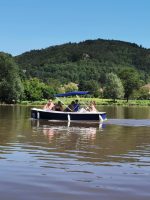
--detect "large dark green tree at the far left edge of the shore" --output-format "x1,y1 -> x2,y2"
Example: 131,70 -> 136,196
0,53 -> 23,103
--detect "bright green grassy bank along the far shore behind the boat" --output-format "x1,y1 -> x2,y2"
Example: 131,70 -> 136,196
6,98 -> 150,106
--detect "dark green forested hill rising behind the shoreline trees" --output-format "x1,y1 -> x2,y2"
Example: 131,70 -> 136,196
14,39 -> 150,86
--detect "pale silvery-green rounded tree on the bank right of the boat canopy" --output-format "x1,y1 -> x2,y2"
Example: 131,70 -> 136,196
104,73 -> 124,102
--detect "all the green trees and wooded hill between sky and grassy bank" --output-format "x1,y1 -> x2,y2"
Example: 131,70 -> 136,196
0,39 -> 150,103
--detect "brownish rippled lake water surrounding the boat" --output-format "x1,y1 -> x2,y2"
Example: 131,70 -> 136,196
0,106 -> 150,200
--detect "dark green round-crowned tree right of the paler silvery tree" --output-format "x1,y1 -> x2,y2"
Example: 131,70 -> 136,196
119,68 -> 140,102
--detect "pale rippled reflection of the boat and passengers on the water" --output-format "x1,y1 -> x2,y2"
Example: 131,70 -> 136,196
31,120 -> 104,142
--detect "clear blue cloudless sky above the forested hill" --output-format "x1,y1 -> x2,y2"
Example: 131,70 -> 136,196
0,0 -> 150,55
